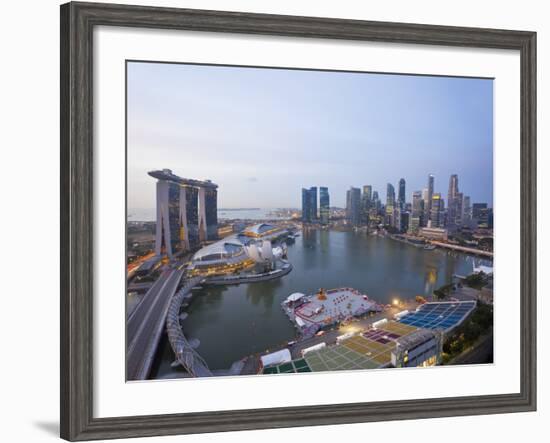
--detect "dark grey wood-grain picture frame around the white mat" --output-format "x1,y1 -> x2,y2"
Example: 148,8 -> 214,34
60,3 -> 536,441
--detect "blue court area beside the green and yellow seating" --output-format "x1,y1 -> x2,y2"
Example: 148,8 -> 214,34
399,301 -> 476,331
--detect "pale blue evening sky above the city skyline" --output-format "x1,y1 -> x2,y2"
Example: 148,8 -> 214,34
127,62 -> 493,209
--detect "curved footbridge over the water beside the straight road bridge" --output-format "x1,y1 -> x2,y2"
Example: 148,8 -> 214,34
166,277 -> 213,377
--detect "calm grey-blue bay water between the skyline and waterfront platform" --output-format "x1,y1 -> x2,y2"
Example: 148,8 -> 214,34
152,230 -> 488,378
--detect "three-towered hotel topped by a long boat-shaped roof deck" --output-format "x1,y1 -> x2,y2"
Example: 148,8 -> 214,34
149,169 -> 218,258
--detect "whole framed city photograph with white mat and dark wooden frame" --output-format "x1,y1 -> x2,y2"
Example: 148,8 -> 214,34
61,3 -> 536,441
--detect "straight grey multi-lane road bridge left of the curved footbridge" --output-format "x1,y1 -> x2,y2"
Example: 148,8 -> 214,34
126,269 -> 183,380
